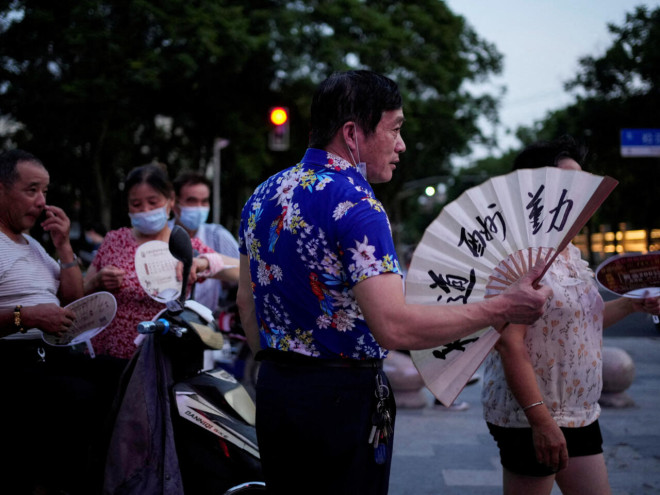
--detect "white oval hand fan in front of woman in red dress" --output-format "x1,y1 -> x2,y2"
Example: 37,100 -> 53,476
135,241 -> 181,303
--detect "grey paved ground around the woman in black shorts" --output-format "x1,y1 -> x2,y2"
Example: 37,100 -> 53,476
390,338 -> 660,495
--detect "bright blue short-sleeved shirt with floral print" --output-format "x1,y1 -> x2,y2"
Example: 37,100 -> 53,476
239,148 -> 401,359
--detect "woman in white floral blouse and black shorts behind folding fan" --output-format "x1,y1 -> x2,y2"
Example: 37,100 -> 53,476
482,137 -> 660,495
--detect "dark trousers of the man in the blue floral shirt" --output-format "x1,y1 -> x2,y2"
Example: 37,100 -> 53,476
256,361 -> 396,495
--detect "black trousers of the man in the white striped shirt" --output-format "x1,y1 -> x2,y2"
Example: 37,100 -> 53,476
0,340 -> 123,495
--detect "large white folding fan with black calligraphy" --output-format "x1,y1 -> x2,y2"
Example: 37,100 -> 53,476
405,167 -> 618,406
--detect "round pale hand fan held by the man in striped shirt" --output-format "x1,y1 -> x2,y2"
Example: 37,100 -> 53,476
41,292 -> 117,346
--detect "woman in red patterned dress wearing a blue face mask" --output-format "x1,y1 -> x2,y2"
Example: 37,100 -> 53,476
85,164 -> 238,360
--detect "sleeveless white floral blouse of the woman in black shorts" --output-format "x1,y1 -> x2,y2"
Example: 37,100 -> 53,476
482,244 -> 604,428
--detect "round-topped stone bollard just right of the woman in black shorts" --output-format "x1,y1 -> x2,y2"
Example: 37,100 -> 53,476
598,347 -> 635,408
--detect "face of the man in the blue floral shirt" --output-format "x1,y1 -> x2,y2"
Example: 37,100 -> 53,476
358,108 -> 406,184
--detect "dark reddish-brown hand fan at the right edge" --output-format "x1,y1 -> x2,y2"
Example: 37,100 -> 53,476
596,251 -> 660,298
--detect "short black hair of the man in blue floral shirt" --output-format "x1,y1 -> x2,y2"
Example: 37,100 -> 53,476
309,70 -> 402,148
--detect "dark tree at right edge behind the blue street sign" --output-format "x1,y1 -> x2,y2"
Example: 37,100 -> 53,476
518,6 -> 660,239
